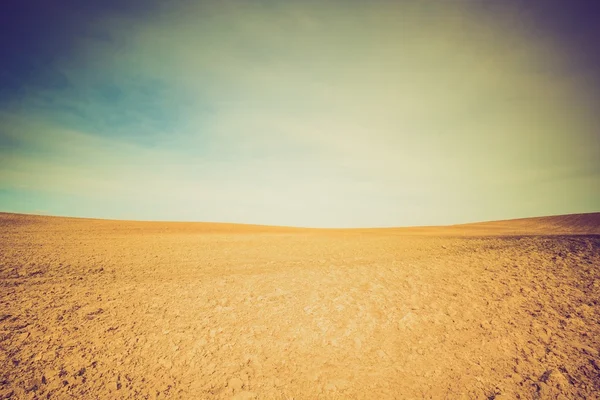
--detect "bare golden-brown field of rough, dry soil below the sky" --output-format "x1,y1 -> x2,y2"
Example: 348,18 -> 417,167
0,214 -> 600,399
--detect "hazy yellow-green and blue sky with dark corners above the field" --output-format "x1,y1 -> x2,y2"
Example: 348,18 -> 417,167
0,0 -> 600,227
